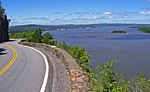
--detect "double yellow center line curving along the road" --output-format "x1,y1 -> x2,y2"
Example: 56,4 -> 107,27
0,44 -> 17,75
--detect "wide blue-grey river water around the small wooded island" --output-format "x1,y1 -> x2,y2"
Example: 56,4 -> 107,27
45,26 -> 150,78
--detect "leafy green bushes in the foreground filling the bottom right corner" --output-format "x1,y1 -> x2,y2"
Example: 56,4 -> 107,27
89,60 -> 150,92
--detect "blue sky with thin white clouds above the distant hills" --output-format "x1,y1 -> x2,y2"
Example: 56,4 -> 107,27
1,0 -> 150,25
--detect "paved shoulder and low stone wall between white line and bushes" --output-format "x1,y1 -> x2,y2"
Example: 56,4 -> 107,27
19,42 -> 89,92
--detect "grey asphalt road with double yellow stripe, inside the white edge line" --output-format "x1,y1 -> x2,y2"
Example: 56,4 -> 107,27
0,42 -> 46,92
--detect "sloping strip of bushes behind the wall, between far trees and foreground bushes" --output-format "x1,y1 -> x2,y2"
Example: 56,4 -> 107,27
54,41 -> 90,72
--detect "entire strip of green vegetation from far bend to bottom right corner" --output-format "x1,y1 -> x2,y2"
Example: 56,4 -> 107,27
10,29 -> 150,92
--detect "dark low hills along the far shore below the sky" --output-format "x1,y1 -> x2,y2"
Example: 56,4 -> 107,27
9,23 -> 150,33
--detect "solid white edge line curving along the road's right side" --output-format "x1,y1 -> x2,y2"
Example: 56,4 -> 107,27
21,45 -> 49,92
